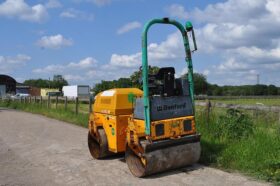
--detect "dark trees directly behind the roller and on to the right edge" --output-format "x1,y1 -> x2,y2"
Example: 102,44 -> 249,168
93,66 -> 280,96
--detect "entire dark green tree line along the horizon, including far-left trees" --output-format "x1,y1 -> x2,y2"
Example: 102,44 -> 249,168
24,70 -> 280,96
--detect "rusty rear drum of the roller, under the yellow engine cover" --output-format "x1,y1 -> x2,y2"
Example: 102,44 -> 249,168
88,129 -> 111,159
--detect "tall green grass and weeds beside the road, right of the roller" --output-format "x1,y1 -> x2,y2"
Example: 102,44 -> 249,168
197,109 -> 280,184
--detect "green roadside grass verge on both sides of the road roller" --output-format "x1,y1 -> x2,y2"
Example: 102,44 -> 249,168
0,101 -> 280,185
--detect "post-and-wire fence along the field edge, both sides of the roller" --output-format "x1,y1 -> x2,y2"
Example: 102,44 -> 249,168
0,96 -> 280,115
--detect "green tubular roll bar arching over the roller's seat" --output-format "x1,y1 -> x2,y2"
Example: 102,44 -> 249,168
142,18 -> 197,135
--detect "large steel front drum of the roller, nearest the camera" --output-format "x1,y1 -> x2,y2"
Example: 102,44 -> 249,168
125,137 -> 201,177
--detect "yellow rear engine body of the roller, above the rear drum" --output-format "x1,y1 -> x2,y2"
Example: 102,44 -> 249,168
89,88 -> 142,153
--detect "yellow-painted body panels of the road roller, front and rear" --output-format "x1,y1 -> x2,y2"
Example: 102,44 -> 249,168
89,88 -> 196,155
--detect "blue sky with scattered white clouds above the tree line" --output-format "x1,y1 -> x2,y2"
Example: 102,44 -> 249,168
0,0 -> 280,86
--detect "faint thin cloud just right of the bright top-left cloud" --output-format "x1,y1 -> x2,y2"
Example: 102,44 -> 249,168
59,8 -> 94,21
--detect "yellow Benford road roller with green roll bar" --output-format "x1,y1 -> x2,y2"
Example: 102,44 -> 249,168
88,18 -> 201,177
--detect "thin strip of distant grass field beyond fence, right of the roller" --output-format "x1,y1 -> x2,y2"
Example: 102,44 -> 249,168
197,98 -> 280,106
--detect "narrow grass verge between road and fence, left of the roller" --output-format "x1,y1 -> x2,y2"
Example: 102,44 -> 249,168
0,101 -> 88,128
